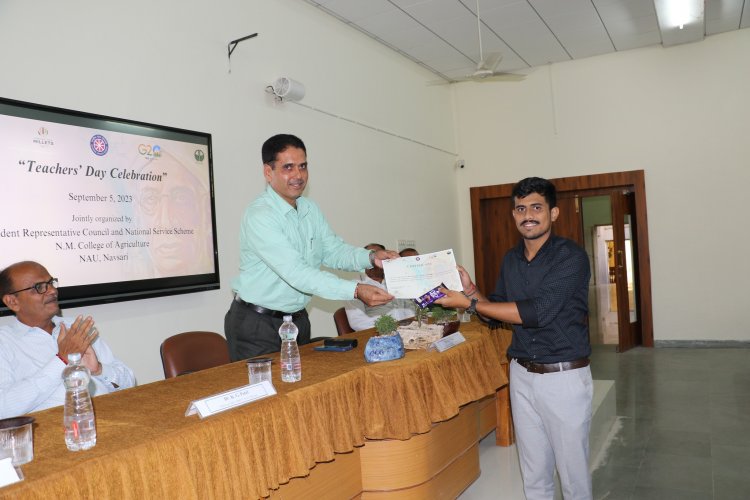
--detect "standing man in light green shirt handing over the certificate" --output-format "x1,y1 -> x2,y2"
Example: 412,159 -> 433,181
224,134 -> 398,361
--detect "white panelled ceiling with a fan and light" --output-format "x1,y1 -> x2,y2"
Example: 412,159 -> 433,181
306,0 -> 750,81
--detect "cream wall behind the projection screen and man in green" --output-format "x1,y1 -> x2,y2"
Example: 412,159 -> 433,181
0,0 -> 458,383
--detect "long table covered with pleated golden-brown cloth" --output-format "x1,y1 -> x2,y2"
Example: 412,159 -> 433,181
0,322 -> 507,500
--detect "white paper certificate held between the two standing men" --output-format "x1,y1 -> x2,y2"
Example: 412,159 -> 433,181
383,249 -> 463,299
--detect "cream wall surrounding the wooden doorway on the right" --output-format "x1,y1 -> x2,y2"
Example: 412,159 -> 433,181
454,30 -> 750,340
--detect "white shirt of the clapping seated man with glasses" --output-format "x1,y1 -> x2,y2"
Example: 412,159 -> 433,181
0,316 -> 135,418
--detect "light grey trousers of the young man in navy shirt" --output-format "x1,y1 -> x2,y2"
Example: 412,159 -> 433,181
510,360 -> 594,500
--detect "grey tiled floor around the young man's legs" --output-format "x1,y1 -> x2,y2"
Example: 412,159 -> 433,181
461,346 -> 750,500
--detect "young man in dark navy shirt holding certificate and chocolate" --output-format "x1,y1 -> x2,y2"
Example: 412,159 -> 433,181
437,177 -> 593,500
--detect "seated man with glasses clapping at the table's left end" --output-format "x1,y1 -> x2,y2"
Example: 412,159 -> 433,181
0,261 -> 135,418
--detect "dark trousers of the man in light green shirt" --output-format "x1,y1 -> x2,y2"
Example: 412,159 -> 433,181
224,300 -> 310,361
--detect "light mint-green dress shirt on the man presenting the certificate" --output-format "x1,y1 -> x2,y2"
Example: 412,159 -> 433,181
232,185 -> 372,313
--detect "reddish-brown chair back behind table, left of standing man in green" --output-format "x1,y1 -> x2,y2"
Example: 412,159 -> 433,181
159,332 -> 231,378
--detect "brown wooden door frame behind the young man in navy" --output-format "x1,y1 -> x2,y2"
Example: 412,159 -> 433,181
469,170 -> 654,347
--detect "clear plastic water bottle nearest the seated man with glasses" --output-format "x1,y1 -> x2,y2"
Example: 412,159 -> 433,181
63,352 -> 96,451
